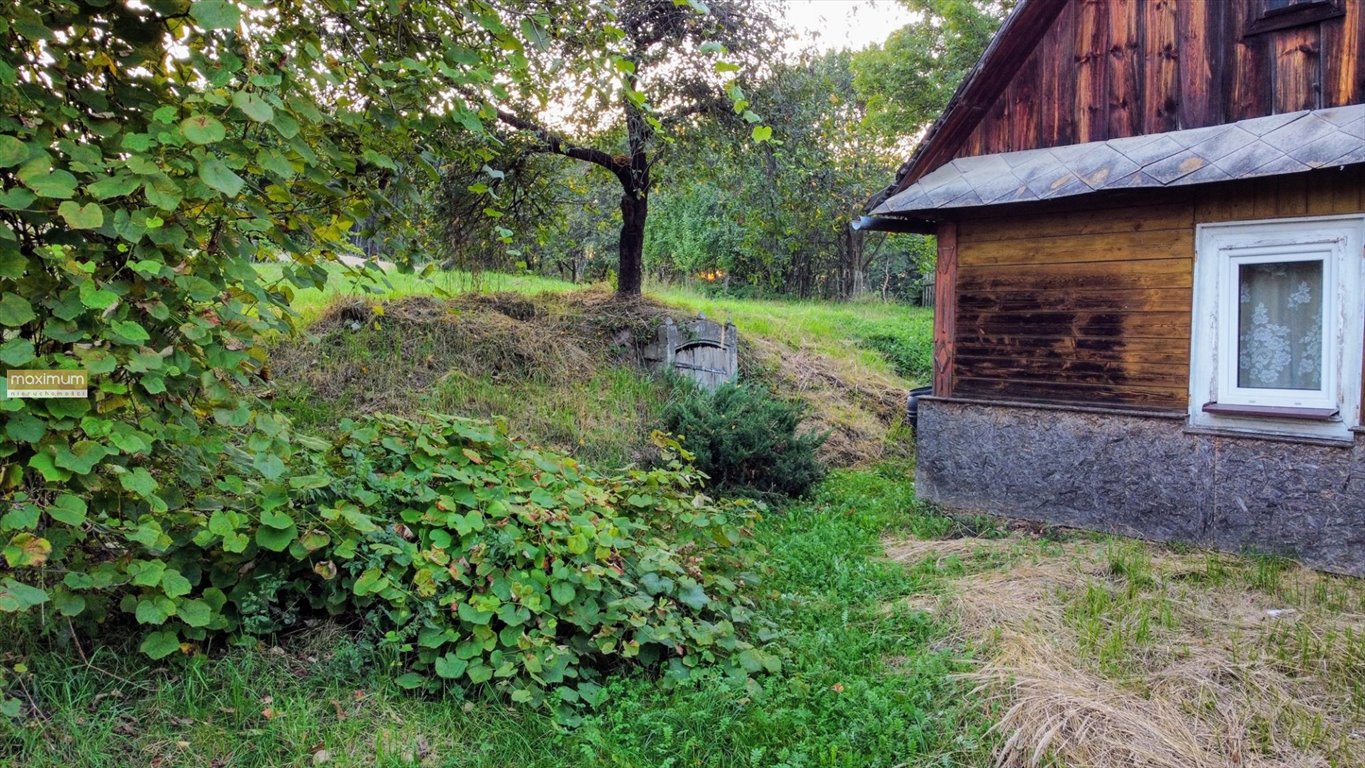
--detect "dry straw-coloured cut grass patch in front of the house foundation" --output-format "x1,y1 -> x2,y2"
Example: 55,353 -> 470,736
887,536 -> 1365,768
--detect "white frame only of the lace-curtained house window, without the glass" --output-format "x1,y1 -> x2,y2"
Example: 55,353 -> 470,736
1189,214 -> 1365,439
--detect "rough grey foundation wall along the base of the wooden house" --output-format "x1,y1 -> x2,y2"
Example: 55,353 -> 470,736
916,398 -> 1365,576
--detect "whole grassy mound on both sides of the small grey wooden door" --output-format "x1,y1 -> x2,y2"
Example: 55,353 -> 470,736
272,289 -> 917,467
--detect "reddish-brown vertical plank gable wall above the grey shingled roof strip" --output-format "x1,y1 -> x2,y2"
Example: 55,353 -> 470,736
957,0 -> 1365,157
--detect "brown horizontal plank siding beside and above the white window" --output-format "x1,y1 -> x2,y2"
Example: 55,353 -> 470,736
935,166 -> 1365,411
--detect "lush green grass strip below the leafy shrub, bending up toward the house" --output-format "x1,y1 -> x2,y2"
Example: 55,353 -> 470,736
0,467 -> 992,768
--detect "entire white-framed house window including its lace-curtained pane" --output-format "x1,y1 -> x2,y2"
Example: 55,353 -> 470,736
1190,216 -> 1365,438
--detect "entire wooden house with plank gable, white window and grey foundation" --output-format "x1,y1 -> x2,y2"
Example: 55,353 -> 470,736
860,0 -> 1365,574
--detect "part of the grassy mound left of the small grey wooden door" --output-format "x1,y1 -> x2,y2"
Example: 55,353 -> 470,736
270,291 -> 669,465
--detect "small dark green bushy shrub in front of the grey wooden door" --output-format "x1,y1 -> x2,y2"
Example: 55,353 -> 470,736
665,385 -> 827,497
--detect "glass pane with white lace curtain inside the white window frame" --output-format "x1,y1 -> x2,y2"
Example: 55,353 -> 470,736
1237,261 -> 1323,390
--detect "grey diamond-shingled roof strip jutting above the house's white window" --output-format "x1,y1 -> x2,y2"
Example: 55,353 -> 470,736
871,105 -> 1365,217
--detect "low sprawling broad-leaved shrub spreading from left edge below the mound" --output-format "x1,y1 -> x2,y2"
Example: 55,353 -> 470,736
0,416 -> 777,704
